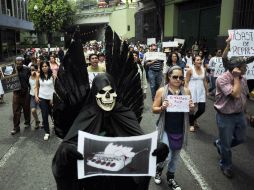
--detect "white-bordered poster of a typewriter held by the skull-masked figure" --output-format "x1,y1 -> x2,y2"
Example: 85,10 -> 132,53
78,131 -> 158,179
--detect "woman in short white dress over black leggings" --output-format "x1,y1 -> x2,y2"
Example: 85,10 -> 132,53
185,55 -> 207,132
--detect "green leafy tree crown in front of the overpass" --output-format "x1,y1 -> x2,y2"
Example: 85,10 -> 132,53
28,0 -> 76,33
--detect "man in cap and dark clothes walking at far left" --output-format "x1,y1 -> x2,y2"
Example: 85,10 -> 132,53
11,57 -> 31,135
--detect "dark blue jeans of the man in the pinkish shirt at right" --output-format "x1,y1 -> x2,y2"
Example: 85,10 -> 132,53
216,113 -> 247,169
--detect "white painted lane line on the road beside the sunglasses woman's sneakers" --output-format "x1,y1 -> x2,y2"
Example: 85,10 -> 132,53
180,149 -> 211,190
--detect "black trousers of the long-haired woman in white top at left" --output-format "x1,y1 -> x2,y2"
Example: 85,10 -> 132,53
40,98 -> 51,134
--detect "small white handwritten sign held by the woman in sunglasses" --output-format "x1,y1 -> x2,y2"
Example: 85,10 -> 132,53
167,95 -> 190,112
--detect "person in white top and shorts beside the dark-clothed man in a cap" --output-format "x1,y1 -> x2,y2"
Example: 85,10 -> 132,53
29,64 -> 40,129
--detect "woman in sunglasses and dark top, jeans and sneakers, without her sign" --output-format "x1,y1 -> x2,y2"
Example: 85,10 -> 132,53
153,66 -> 194,190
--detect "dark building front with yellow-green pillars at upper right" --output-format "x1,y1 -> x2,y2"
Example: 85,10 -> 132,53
136,0 -> 254,52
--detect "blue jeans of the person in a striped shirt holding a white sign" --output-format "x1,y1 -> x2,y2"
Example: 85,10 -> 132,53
148,69 -> 162,100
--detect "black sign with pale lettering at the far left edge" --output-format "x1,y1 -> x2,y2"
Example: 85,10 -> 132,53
0,63 -> 21,93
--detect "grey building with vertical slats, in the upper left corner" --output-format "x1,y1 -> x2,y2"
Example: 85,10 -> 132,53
0,0 -> 33,59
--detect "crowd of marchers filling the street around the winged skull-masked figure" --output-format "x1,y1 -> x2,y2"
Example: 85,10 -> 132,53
0,36 -> 254,190
